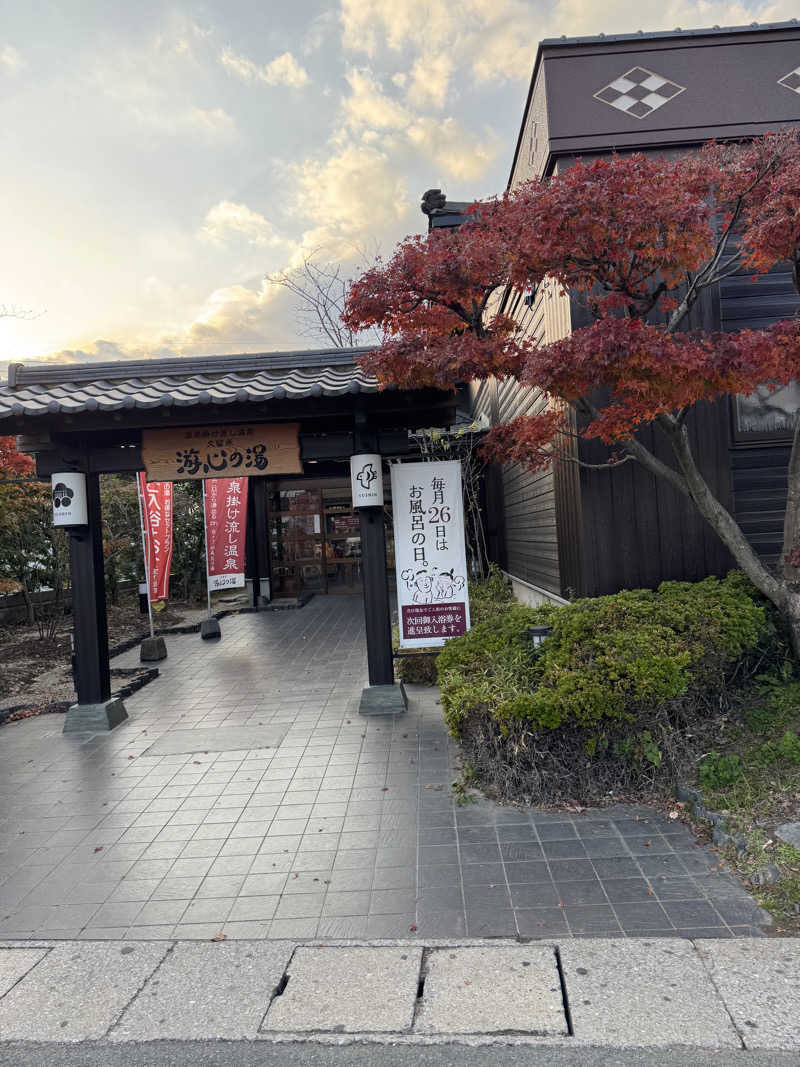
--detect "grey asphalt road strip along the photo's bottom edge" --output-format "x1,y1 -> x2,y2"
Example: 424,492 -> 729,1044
0,1041 -> 800,1067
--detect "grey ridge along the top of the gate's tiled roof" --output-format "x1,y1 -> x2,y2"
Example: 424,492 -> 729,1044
7,346 -> 370,389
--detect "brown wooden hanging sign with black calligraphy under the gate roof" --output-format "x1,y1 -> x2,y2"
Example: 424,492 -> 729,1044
142,423 -> 303,481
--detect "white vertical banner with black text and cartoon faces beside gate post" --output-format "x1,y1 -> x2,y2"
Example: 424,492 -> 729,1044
391,460 -> 469,649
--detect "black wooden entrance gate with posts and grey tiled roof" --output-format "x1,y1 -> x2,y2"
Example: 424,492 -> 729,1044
0,349 -> 458,731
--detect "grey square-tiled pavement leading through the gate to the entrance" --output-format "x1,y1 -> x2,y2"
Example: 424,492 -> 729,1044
0,596 -> 765,939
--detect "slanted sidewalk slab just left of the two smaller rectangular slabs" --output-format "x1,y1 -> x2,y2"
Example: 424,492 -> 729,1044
111,941 -> 294,1041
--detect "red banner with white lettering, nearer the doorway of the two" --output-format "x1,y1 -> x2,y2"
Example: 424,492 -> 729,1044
204,478 -> 247,592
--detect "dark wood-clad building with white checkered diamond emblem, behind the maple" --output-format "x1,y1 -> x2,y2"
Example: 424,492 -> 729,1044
469,20 -> 800,601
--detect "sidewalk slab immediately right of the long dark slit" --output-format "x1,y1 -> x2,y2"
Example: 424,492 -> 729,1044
559,939 -> 741,1049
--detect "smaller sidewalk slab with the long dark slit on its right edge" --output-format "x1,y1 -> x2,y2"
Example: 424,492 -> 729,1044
414,944 -> 566,1035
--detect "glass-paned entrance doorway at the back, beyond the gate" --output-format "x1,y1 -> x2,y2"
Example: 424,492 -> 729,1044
269,477 -> 395,598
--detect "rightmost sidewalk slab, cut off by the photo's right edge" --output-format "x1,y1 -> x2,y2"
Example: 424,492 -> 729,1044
698,938 -> 800,1049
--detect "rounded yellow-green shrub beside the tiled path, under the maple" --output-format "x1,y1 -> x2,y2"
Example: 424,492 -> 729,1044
437,572 -> 779,800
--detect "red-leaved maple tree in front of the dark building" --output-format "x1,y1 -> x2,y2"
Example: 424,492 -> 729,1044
343,130 -> 800,655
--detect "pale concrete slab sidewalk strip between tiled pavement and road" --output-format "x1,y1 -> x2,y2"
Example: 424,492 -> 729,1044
0,938 -> 800,1049
